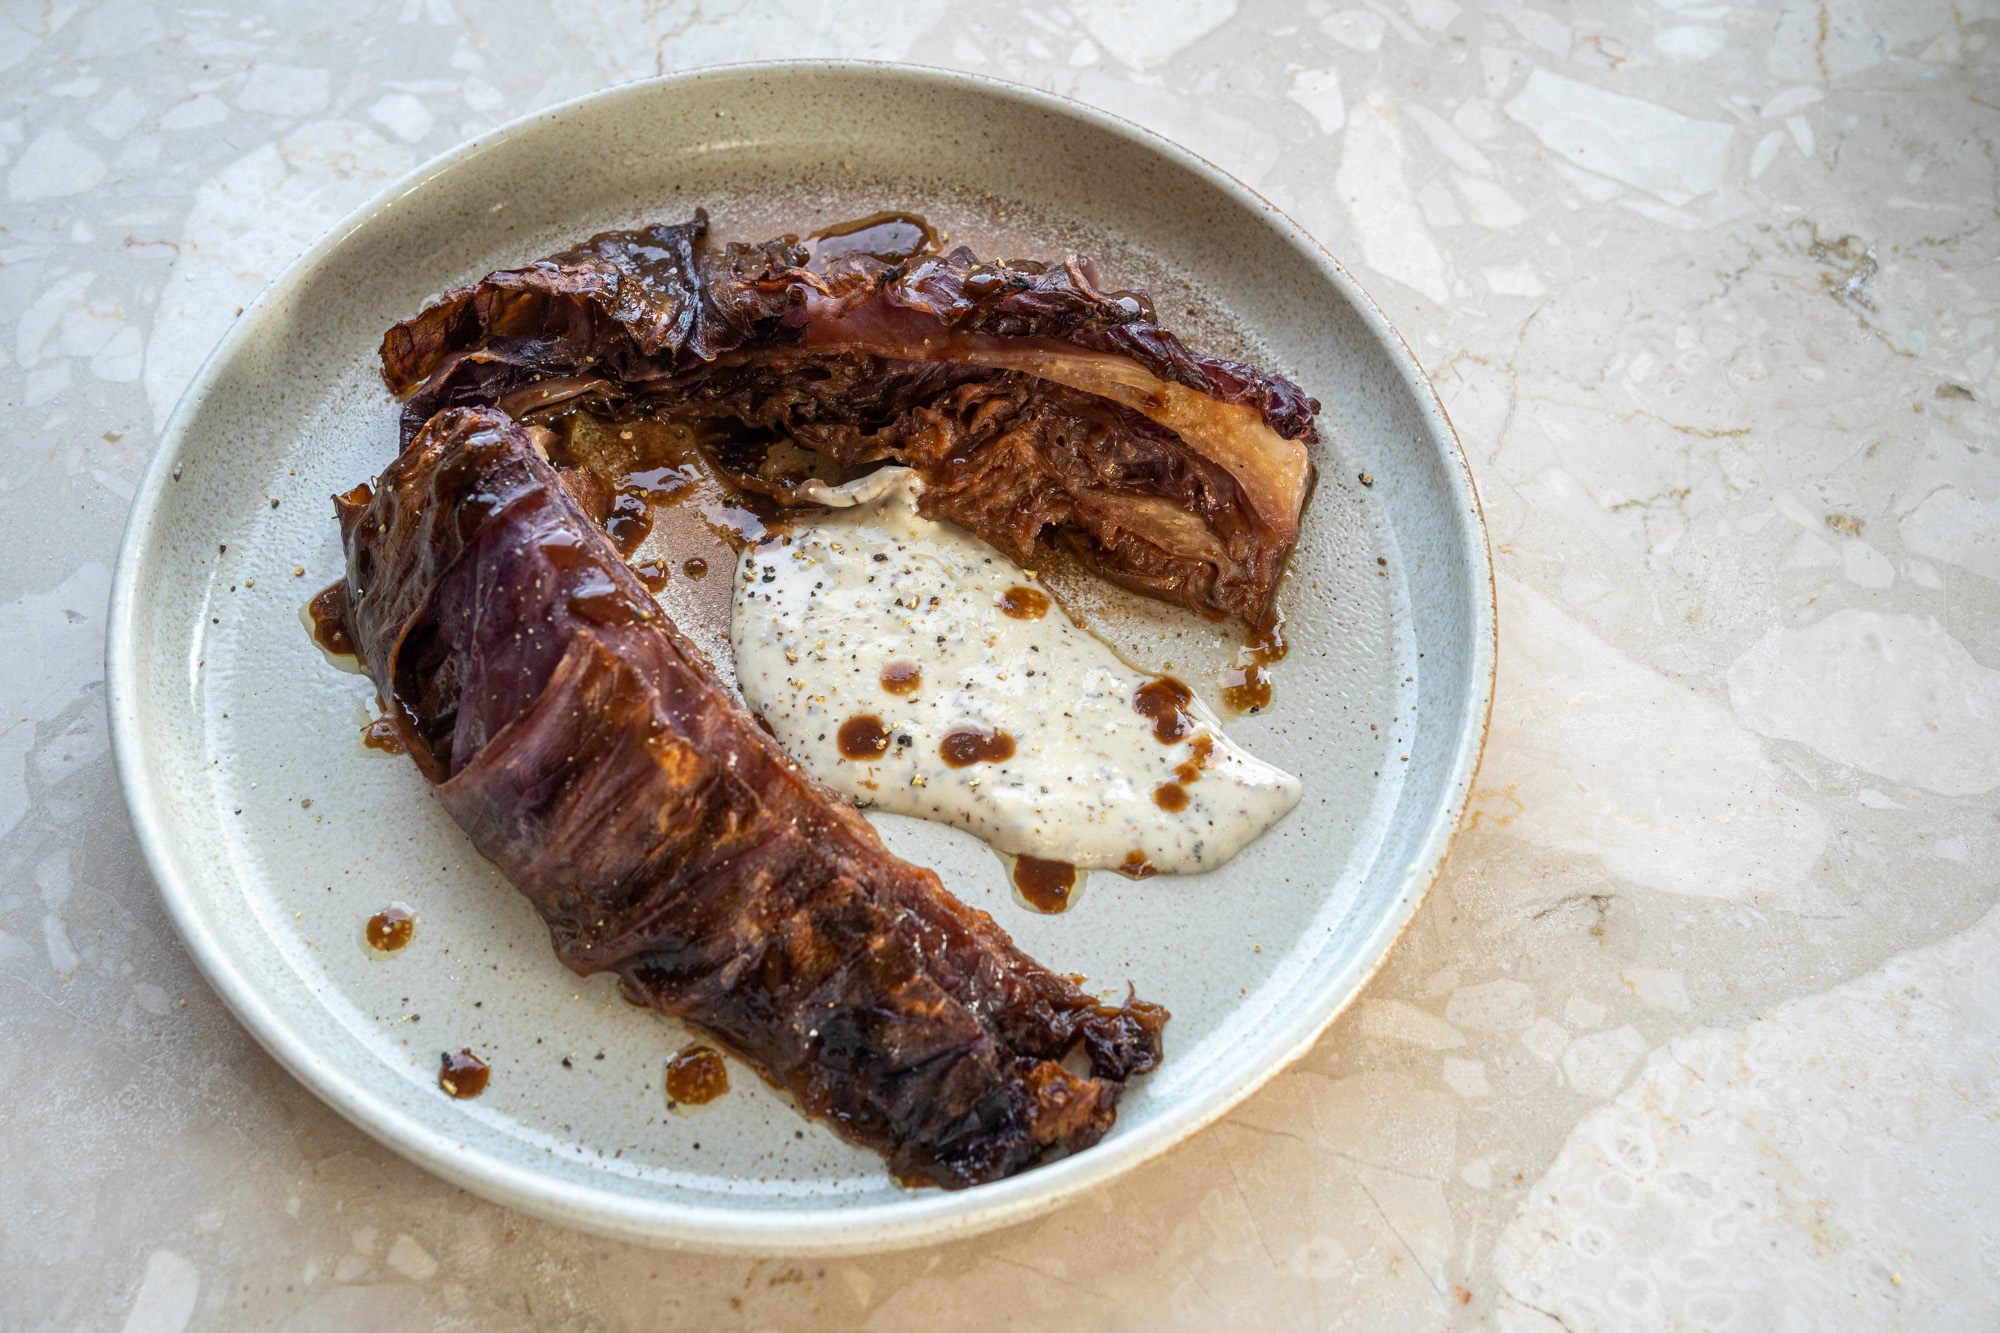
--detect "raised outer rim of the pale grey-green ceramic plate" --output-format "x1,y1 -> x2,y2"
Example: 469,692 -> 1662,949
104,60 -> 1498,1257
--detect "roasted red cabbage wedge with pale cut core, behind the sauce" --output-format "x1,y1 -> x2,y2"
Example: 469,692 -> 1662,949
382,212 -> 1320,628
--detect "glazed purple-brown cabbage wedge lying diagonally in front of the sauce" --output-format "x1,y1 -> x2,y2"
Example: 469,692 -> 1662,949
336,408 -> 1166,1187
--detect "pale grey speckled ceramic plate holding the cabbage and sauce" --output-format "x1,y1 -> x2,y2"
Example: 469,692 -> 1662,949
108,64 -> 1494,1253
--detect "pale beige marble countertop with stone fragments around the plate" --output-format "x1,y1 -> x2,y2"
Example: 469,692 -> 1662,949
0,0 -> 2000,1333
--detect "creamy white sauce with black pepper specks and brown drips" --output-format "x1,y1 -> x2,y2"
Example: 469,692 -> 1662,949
730,468 -> 1300,875
